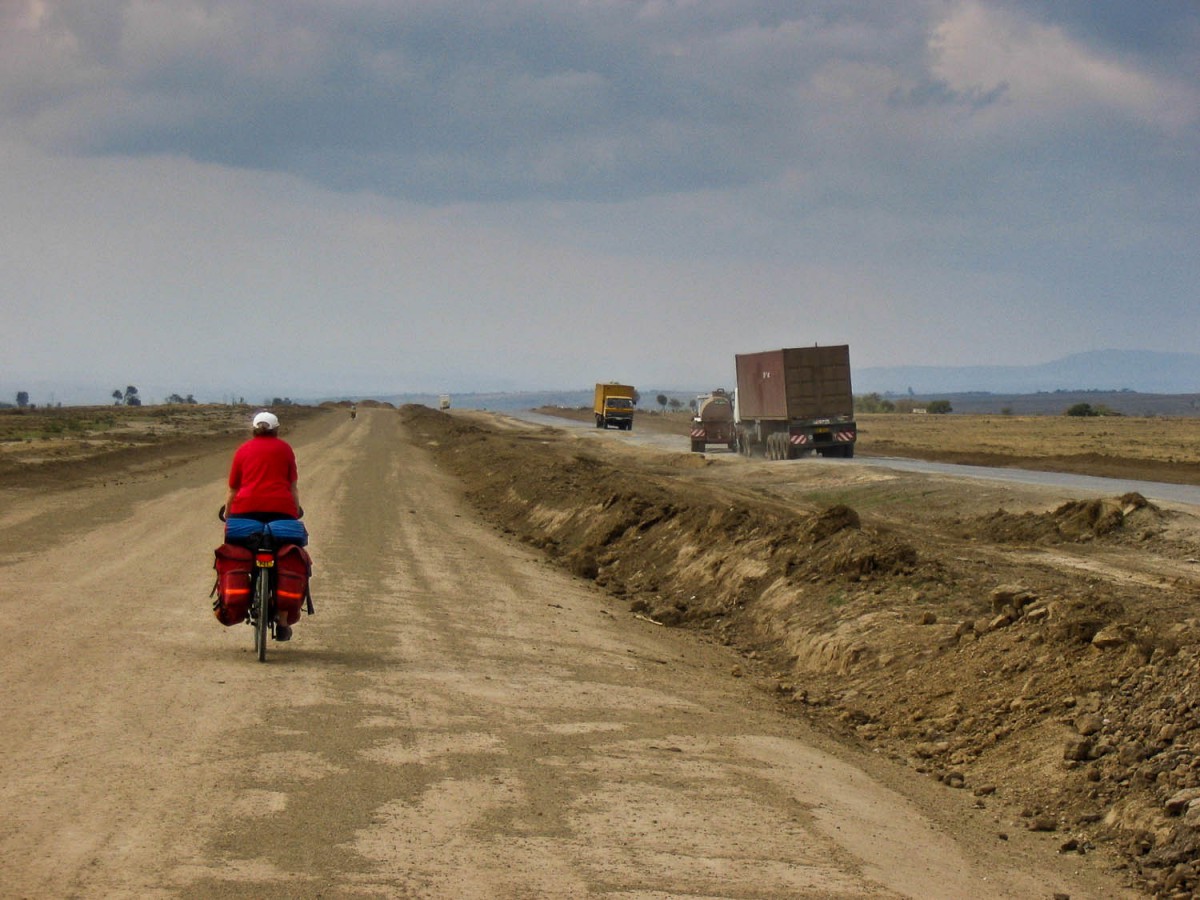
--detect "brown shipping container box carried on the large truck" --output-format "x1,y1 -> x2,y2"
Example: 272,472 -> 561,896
734,344 -> 854,421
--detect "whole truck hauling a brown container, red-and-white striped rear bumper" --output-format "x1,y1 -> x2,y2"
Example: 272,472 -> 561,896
734,344 -> 858,460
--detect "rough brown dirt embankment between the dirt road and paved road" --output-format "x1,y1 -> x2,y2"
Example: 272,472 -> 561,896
401,407 -> 1200,896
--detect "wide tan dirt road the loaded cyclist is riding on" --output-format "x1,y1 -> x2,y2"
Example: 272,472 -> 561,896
0,409 -> 1122,898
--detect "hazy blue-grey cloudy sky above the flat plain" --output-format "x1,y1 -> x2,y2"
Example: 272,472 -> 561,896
0,0 -> 1200,402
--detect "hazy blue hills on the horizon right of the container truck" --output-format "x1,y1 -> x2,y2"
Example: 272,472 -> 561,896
853,350 -> 1200,396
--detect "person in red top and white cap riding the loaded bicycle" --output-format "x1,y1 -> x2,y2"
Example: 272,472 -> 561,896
224,412 -> 302,641
